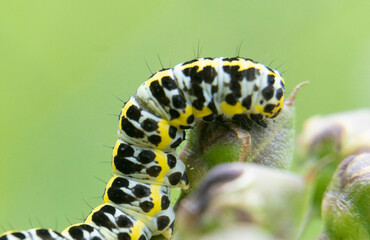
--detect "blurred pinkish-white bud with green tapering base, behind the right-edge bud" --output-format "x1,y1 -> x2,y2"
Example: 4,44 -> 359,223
297,109 -> 370,216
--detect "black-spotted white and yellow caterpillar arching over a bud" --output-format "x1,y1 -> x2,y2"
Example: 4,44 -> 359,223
0,57 -> 285,240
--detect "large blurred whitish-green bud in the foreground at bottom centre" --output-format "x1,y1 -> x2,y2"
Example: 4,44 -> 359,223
177,163 -> 309,239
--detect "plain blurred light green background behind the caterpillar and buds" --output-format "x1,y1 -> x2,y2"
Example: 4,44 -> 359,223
0,0 -> 370,236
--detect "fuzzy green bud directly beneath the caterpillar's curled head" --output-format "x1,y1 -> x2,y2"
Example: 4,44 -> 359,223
180,83 -> 306,188
